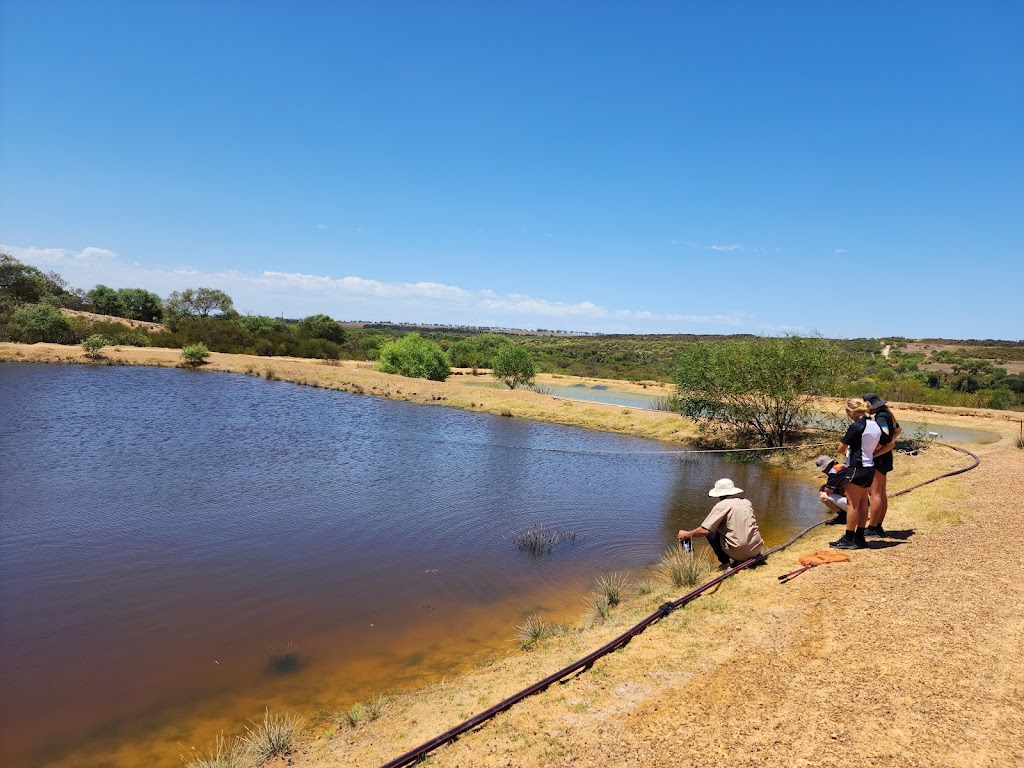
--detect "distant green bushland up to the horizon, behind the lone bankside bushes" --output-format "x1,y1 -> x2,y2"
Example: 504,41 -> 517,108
0,254 -> 1024,409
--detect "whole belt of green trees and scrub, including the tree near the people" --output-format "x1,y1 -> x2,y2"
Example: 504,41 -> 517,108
0,254 -> 1024,444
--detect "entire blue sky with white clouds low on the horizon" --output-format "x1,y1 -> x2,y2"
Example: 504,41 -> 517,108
0,0 -> 1024,340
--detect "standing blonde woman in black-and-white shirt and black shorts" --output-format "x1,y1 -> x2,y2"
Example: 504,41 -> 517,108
828,397 -> 882,549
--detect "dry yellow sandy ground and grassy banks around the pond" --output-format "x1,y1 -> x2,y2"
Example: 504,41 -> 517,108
0,343 -> 1024,768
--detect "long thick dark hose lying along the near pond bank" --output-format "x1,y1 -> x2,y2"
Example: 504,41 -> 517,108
382,442 -> 981,768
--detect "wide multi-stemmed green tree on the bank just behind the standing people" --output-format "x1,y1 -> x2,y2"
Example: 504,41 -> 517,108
673,336 -> 849,446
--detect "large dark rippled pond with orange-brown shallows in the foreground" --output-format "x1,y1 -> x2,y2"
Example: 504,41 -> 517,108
0,364 -> 823,767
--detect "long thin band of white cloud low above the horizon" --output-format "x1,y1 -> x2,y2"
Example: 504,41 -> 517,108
0,245 -> 748,333
